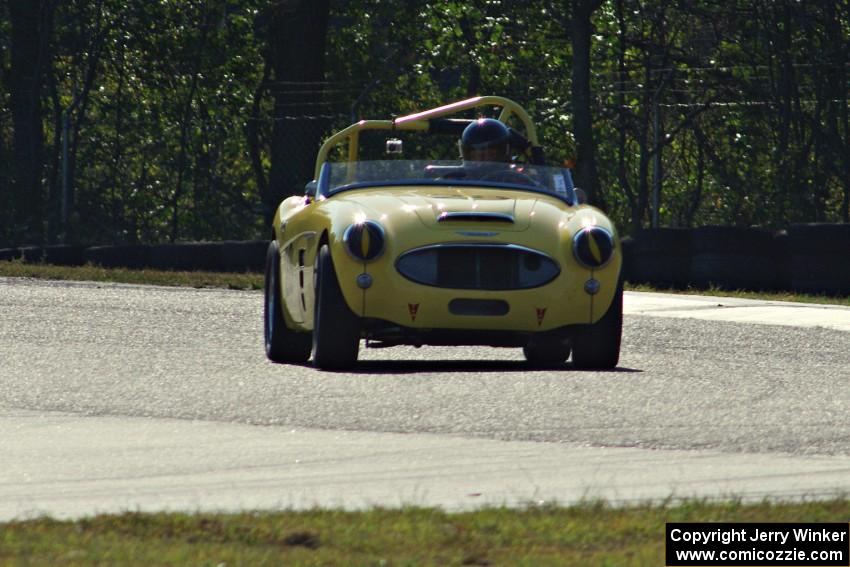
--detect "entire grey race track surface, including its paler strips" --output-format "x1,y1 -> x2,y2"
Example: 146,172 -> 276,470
0,278 -> 850,520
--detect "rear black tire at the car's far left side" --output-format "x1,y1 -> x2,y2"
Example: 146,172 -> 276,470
263,240 -> 312,363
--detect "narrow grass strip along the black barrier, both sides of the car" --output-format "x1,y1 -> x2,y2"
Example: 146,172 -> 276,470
0,260 -> 850,306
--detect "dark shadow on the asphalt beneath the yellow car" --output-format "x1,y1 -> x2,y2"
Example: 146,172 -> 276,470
318,360 -> 643,375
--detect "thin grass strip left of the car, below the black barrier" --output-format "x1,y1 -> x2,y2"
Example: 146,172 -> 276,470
0,260 -> 263,289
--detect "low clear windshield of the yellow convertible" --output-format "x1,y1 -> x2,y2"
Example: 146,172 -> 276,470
318,160 -> 576,205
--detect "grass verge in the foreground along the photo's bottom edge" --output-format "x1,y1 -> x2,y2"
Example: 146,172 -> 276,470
0,499 -> 850,566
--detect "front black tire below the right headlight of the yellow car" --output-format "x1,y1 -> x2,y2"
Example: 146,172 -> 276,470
573,283 -> 623,370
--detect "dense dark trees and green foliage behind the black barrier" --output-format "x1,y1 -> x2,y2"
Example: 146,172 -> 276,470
0,0 -> 850,244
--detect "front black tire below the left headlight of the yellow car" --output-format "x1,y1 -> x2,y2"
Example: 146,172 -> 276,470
313,244 -> 360,370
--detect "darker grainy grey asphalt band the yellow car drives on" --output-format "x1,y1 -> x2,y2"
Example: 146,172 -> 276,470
0,279 -> 850,515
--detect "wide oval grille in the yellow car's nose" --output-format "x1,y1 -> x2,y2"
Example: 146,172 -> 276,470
396,244 -> 561,291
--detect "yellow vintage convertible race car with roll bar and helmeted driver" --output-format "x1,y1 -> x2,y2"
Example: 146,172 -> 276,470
264,96 -> 623,369
